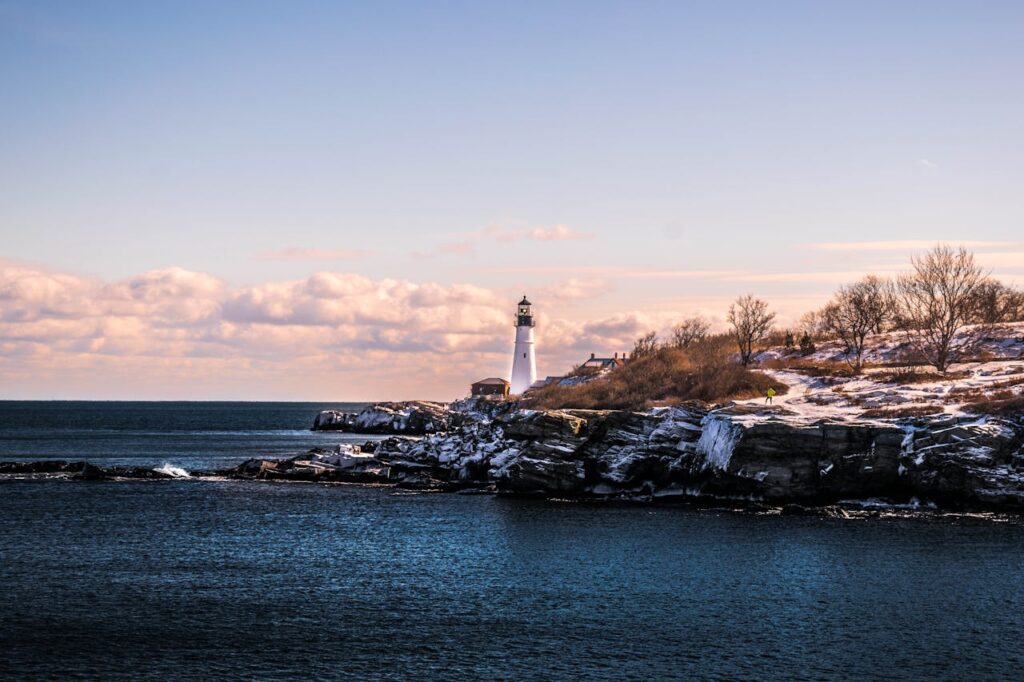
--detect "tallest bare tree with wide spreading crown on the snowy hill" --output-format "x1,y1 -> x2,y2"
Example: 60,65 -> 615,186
896,246 -> 985,372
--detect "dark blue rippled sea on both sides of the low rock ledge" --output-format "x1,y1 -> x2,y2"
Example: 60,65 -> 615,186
0,402 -> 1024,681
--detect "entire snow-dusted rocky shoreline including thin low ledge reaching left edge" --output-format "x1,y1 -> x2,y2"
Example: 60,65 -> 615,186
0,401 -> 1024,514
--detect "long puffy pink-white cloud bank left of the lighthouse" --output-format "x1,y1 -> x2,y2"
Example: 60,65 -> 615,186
0,264 -> 514,383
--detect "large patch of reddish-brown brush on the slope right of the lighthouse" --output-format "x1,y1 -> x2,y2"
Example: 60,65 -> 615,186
526,336 -> 788,410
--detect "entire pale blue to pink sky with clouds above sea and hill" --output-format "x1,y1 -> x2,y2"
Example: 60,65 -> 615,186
0,0 -> 1024,400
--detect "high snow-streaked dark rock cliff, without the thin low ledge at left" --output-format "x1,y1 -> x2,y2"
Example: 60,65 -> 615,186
313,406 -> 1024,509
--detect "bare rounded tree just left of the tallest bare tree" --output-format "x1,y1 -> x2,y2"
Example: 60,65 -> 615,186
821,275 -> 890,372
